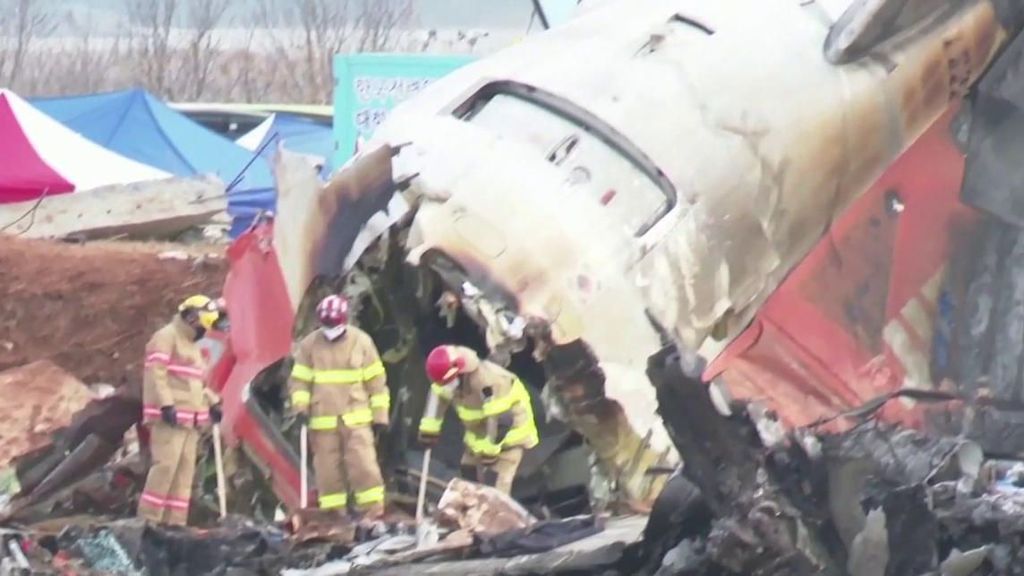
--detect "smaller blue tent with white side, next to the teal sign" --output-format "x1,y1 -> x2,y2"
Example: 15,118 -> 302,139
236,113 -> 335,179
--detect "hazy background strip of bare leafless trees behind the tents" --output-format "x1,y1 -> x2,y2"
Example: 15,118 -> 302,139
0,0 -> 423,104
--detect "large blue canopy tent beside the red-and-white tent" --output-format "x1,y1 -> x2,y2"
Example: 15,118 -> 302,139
32,89 -> 276,236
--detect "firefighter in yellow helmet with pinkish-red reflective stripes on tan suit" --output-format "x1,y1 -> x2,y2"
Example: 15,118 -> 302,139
138,295 -> 226,526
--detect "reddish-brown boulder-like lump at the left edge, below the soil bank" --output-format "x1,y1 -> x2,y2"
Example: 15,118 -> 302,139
0,360 -> 93,465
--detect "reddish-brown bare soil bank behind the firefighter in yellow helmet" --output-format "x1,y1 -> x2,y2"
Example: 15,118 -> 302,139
0,236 -> 227,385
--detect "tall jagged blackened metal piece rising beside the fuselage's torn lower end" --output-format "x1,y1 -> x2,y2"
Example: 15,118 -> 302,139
649,342 -> 844,575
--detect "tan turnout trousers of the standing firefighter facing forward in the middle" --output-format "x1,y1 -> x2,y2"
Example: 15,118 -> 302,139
309,424 -> 384,516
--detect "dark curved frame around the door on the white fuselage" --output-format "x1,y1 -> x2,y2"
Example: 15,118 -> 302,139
452,80 -> 679,238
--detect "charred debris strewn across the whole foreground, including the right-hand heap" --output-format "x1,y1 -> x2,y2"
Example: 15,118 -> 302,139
6,346 -> 1024,576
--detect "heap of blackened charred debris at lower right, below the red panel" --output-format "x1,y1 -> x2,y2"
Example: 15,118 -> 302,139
633,344 -> 1024,576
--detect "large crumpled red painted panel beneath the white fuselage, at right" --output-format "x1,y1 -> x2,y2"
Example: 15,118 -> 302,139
705,110 -> 977,425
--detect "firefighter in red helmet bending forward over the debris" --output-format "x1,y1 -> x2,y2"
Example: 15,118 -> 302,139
420,345 -> 539,494
